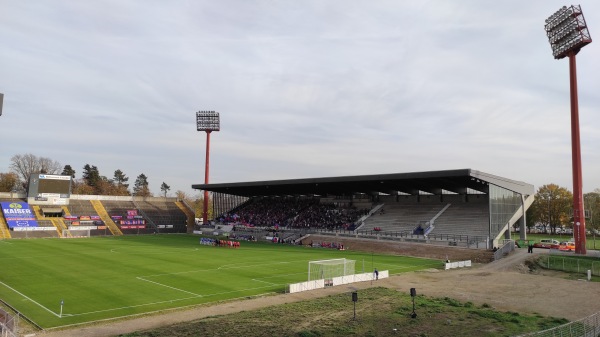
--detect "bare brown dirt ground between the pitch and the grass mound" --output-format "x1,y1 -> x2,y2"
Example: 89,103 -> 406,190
34,237 -> 600,337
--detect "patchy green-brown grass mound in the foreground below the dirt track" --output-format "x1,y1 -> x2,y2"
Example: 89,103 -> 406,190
121,288 -> 568,337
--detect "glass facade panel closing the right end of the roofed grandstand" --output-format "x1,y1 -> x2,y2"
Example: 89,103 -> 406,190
490,184 -> 521,238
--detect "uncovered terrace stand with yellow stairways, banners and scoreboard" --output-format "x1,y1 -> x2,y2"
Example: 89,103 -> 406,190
0,174 -> 194,239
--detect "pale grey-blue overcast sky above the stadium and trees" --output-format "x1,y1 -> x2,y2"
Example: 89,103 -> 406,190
0,0 -> 600,195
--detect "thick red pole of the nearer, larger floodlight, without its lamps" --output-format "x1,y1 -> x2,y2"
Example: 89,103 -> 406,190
569,51 -> 587,255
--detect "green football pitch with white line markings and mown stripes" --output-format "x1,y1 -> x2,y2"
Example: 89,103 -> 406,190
0,235 -> 442,329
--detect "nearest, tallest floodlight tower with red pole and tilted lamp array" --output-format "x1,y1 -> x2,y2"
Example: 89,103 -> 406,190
544,6 -> 592,255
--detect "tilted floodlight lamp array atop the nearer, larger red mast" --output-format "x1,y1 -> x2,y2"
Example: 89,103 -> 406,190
544,6 -> 592,59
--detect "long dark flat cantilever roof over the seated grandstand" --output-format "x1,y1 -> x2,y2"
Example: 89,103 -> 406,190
192,169 -> 534,197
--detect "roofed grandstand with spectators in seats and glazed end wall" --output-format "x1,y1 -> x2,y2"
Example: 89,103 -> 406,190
192,169 -> 534,249
